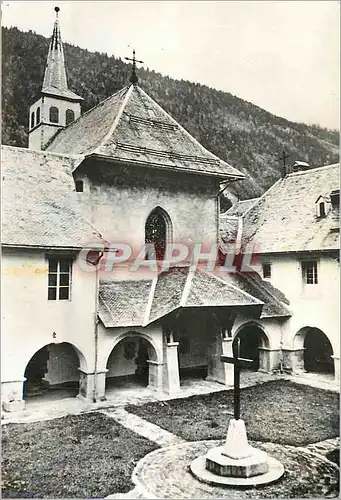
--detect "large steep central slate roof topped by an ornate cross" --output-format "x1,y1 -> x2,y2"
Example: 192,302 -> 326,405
47,85 -> 244,179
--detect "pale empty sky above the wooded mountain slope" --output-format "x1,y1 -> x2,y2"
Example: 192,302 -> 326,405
2,0 -> 340,128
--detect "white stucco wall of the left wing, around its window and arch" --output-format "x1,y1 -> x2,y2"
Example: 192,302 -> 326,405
1,248 -> 96,388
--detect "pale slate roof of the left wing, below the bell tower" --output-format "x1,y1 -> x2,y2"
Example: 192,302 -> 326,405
1,146 -> 101,248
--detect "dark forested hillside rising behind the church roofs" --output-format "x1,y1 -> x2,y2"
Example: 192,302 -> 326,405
2,28 -> 339,199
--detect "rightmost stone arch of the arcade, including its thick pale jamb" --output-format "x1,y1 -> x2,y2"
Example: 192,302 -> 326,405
294,326 -> 334,373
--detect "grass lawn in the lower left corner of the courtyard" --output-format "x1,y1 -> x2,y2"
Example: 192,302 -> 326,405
2,413 -> 157,498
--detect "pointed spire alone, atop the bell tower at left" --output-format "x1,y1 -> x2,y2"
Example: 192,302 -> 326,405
42,7 -> 68,91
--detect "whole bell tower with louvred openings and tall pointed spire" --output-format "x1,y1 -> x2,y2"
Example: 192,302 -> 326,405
28,7 -> 83,150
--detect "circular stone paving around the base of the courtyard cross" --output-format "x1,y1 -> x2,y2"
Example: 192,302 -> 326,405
119,441 -> 339,500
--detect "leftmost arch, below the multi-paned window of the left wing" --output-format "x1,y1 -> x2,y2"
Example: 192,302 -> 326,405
23,342 -> 87,397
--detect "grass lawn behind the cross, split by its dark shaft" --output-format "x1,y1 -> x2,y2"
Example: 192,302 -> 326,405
126,380 -> 339,446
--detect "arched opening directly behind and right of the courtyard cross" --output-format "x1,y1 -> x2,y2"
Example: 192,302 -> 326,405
233,321 -> 270,371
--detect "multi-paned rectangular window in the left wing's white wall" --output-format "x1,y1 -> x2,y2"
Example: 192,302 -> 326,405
48,257 -> 72,300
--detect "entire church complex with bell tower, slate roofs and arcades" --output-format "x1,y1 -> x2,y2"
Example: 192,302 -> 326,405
1,8 -> 339,411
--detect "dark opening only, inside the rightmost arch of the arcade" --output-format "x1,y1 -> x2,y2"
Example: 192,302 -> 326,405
303,328 -> 334,373
